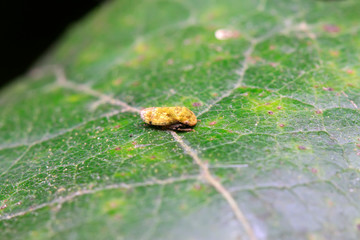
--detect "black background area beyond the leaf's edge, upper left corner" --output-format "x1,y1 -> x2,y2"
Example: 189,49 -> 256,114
0,0 -> 102,88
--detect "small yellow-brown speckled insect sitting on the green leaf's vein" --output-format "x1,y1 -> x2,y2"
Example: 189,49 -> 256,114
140,107 -> 197,132
